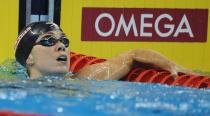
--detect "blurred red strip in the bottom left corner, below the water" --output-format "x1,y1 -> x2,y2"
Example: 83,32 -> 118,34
0,111 -> 44,116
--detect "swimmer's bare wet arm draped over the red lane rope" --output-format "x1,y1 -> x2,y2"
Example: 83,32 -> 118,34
74,49 -> 193,80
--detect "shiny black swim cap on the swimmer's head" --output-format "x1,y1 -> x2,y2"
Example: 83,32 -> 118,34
15,21 -> 62,67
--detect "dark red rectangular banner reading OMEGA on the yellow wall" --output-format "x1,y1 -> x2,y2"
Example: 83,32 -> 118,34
81,8 -> 208,42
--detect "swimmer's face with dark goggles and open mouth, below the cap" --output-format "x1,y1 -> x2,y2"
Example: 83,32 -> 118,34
28,31 -> 70,78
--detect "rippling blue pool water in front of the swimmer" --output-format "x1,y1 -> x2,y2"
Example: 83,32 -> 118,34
0,59 -> 210,116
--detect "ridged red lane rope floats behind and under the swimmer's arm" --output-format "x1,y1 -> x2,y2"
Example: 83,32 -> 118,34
69,53 -> 210,88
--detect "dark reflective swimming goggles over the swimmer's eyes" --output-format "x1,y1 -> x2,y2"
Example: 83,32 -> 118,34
35,35 -> 69,48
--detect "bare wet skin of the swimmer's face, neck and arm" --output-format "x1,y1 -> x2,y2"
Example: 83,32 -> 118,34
26,31 -> 194,80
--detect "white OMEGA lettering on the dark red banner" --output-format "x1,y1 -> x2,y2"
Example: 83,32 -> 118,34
94,13 -> 194,38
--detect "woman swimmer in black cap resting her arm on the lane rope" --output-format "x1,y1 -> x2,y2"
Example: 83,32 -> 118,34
15,22 -> 193,80
